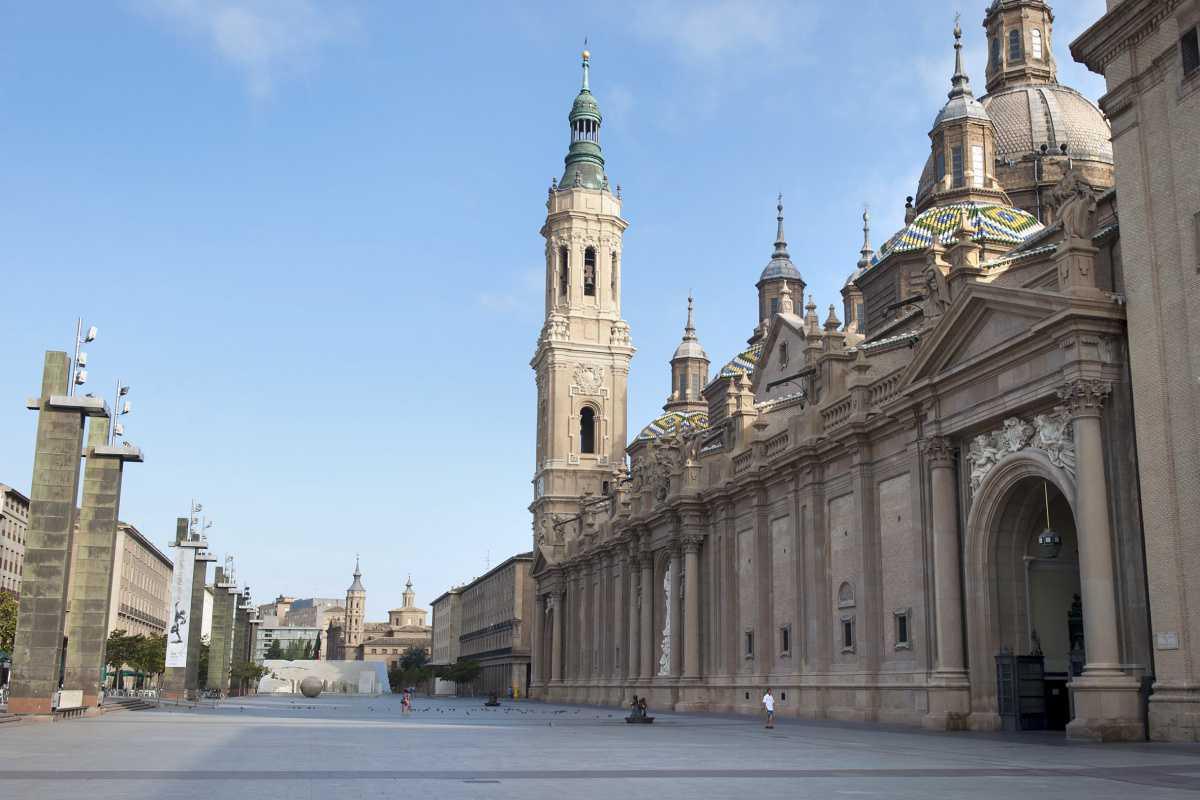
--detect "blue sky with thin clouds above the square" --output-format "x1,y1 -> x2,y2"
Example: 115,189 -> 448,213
0,0 -> 1104,619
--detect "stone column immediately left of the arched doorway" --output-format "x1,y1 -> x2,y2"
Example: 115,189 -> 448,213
923,437 -> 971,729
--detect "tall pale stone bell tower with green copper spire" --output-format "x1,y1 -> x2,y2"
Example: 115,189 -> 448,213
529,50 -> 634,563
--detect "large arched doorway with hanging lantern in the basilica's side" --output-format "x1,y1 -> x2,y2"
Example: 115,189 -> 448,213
964,451 -> 1084,729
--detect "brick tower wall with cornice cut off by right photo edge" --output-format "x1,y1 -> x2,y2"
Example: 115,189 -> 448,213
1072,0 -> 1200,741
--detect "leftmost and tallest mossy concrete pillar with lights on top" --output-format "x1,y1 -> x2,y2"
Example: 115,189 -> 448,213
8,351 -> 108,714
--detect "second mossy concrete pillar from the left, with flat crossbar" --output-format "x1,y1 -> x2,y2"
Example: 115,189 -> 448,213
62,417 -> 142,708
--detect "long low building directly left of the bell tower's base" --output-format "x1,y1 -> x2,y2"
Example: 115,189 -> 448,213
458,553 -> 534,697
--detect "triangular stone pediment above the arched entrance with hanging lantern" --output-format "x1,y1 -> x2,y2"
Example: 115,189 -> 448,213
904,284 -> 1069,385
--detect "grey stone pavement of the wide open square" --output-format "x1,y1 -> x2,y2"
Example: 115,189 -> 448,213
0,696 -> 1200,800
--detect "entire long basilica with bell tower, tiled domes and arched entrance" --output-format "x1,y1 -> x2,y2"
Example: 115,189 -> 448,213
530,0 -> 1180,740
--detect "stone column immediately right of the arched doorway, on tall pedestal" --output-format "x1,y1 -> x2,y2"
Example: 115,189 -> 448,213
1058,380 -> 1145,741
